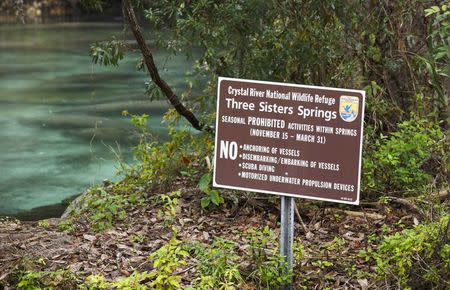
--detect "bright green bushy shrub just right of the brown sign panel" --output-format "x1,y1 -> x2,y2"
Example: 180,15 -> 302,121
363,119 -> 445,193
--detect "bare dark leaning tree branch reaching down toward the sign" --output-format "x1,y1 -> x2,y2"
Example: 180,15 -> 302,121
122,0 -> 212,133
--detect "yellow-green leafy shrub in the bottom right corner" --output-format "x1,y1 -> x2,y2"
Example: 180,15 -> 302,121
372,214 -> 450,289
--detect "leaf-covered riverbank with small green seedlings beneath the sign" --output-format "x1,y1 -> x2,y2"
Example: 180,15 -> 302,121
0,172 -> 448,289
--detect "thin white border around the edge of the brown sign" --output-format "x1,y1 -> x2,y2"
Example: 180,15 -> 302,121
213,77 -> 366,205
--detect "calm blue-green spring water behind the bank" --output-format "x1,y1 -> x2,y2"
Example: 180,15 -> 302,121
0,22 -> 190,216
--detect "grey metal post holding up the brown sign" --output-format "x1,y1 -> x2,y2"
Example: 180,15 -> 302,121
280,196 -> 295,290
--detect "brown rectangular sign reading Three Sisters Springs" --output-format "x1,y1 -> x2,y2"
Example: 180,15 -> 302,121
214,78 -> 365,204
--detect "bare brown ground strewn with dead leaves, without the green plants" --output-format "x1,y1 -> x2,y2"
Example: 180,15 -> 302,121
0,181 -> 442,289
